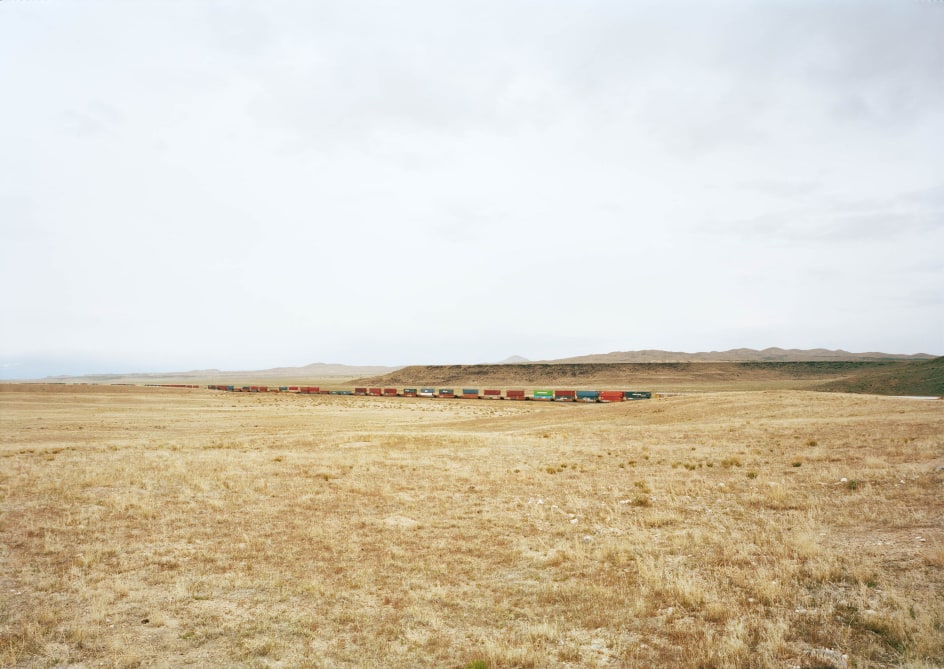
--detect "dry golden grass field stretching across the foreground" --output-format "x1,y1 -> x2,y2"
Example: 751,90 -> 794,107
0,385 -> 944,669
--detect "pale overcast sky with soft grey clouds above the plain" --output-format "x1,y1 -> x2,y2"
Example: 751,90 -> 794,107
0,0 -> 944,379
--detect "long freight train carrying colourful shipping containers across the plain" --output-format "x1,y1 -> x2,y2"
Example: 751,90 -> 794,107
201,384 -> 652,402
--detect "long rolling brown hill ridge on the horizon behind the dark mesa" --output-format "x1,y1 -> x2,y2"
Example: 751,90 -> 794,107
540,347 -> 934,363
